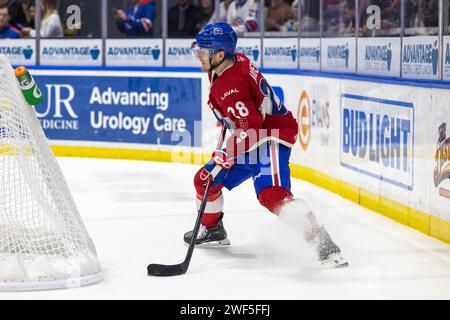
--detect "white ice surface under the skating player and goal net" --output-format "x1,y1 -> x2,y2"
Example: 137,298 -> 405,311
0,158 -> 450,300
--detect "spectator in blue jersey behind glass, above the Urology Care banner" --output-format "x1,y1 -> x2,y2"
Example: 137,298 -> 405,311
114,0 -> 156,37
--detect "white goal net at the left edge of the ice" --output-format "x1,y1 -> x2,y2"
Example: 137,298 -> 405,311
0,55 -> 102,291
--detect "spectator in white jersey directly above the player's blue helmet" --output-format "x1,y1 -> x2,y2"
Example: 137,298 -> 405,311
227,0 -> 259,35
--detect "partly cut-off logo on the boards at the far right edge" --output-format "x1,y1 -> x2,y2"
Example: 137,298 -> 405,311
433,122 -> 450,199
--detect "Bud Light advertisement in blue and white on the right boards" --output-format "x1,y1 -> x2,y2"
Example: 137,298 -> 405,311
341,94 -> 414,190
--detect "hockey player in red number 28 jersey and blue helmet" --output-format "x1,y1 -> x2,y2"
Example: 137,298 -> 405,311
184,23 -> 348,267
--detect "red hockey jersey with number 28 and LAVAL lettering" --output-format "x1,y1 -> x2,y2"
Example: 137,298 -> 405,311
208,53 -> 298,158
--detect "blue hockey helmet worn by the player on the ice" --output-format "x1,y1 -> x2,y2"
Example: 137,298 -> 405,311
193,22 -> 237,58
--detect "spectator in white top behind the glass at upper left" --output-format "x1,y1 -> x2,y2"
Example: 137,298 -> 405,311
22,0 -> 63,38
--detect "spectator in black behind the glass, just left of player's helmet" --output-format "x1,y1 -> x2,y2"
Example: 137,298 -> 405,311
168,0 -> 198,38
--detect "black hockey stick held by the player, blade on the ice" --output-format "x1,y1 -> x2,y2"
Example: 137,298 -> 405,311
147,125 -> 227,277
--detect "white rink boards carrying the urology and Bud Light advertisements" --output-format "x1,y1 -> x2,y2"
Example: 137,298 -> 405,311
29,70 -> 450,241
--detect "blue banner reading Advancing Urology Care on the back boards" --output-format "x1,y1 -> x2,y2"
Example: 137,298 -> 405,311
35,76 -> 201,147
